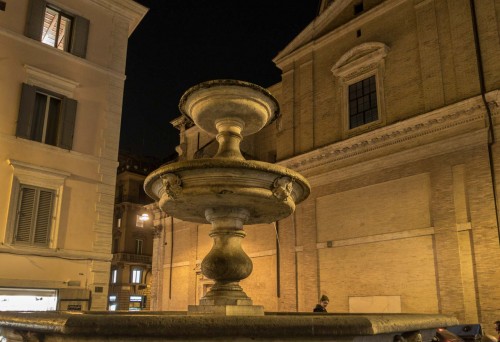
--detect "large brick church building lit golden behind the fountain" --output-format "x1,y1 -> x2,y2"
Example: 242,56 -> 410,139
152,0 -> 500,327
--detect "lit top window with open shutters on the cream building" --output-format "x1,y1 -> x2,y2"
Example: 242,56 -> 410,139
26,0 -> 89,58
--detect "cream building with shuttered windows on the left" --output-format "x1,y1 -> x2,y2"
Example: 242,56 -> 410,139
0,0 -> 147,310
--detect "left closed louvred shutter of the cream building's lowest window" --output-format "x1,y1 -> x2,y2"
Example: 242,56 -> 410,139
15,187 -> 36,243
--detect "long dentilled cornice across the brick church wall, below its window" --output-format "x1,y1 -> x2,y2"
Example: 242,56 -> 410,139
277,96 -> 486,178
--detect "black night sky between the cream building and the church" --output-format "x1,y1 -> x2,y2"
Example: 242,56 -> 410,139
120,0 -> 320,159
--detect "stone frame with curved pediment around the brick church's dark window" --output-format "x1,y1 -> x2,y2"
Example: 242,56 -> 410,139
331,42 -> 389,138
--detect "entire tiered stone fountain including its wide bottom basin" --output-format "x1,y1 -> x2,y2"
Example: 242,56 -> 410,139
0,80 -> 458,342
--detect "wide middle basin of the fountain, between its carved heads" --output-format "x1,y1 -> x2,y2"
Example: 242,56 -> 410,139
144,158 -> 310,224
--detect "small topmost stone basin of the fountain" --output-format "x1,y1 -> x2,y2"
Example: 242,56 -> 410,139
179,79 -> 280,136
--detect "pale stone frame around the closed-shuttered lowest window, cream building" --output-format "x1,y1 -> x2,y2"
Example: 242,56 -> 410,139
4,160 -> 70,249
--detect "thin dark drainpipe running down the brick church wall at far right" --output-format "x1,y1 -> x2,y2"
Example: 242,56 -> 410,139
469,0 -> 500,244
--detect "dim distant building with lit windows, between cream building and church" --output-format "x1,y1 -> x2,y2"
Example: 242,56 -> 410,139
108,154 -> 160,311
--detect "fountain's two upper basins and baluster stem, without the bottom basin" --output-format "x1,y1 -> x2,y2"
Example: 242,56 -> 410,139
144,80 -> 310,315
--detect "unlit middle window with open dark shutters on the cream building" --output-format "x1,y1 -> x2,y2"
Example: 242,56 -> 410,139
16,83 -> 77,150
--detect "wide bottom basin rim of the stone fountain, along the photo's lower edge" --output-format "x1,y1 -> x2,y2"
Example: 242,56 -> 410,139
0,312 -> 458,342
